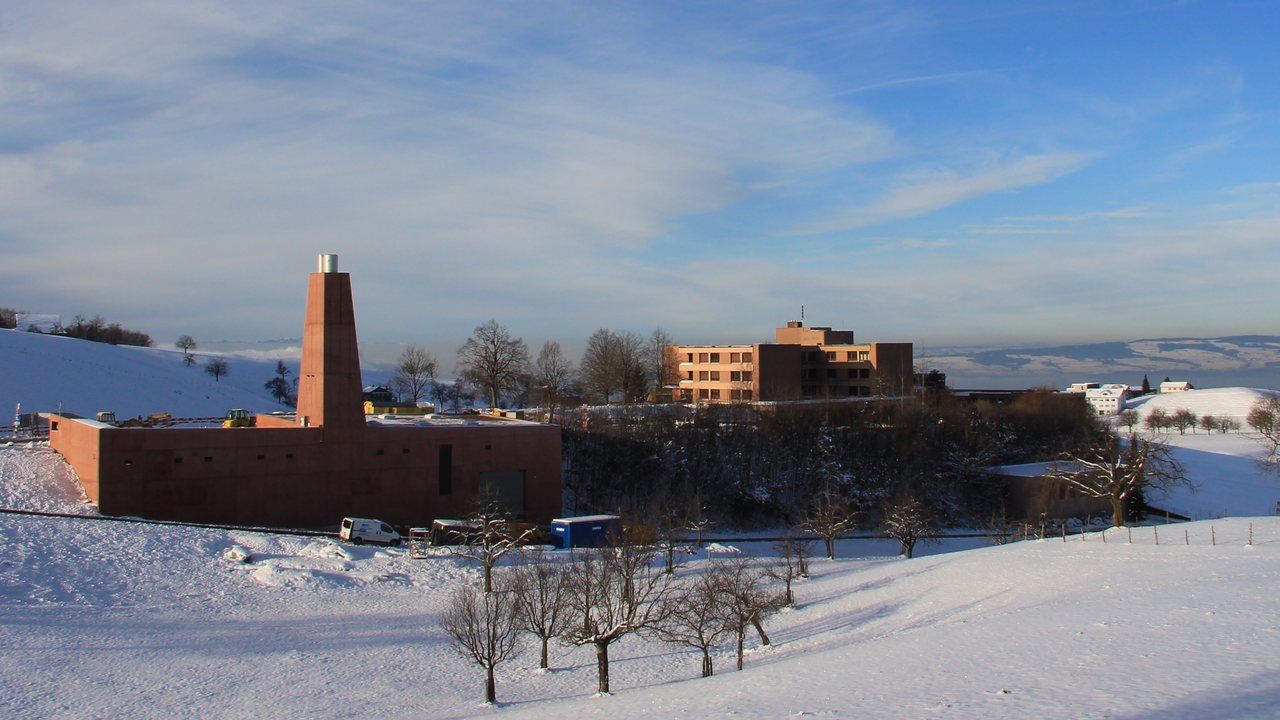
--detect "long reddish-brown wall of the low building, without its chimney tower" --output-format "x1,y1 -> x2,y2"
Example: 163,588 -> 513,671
52,419 -> 561,528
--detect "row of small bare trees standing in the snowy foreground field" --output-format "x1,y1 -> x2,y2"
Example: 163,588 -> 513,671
440,543 -> 778,702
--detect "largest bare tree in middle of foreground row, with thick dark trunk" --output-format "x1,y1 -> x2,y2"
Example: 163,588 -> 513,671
563,546 -> 672,694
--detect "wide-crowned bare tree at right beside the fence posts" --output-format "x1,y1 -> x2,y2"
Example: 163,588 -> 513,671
1048,433 -> 1192,528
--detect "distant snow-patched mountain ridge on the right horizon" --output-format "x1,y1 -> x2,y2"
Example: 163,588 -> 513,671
918,334 -> 1280,388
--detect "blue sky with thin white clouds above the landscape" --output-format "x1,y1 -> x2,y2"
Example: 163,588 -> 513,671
0,0 -> 1280,358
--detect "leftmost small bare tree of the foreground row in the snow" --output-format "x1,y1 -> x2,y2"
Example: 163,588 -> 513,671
440,576 -> 521,702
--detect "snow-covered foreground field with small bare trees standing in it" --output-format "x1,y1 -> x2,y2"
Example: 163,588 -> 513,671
0,446 -> 1280,720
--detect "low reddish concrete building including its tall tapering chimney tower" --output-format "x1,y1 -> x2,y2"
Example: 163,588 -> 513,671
50,255 -> 562,528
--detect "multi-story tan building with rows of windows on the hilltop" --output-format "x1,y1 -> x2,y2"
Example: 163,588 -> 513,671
669,322 -> 913,402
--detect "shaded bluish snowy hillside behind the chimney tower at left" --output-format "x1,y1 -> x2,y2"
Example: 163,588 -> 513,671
0,324 -> 297,419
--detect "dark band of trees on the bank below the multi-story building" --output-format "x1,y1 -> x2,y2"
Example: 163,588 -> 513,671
562,391 -> 1096,527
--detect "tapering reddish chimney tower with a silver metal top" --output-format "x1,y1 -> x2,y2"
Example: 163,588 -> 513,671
297,255 -> 365,429
